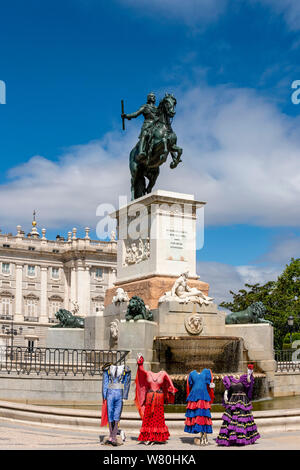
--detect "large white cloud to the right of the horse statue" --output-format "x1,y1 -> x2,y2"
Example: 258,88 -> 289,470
159,86 -> 300,226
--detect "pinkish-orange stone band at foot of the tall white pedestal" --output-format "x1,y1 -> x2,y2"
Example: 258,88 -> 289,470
104,276 -> 209,310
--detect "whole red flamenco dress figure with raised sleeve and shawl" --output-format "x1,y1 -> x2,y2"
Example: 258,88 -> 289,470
135,357 -> 177,442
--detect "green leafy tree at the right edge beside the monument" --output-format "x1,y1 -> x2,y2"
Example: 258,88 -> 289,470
220,258 -> 300,349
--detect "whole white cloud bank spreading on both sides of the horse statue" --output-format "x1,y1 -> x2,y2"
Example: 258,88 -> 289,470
0,84 -> 300,235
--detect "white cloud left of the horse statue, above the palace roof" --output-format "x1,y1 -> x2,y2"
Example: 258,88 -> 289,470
0,134 -> 133,233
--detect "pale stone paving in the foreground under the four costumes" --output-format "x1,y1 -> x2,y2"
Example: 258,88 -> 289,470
0,419 -> 300,455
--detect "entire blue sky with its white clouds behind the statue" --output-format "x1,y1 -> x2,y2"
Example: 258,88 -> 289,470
0,0 -> 300,299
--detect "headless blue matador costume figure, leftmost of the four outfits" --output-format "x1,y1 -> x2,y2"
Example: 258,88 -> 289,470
101,364 -> 131,446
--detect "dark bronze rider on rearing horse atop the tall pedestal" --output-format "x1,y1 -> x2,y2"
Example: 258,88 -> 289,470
122,93 -> 182,200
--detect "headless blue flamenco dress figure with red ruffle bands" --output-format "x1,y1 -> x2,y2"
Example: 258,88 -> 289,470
184,369 -> 215,445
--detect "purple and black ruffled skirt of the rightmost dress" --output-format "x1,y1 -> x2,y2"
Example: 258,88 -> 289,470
216,393 -> 260,446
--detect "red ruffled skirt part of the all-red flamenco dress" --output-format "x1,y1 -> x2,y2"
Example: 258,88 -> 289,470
138,392 -> 170,442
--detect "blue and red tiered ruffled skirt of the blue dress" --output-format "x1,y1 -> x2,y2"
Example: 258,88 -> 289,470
184,400 -> 212,434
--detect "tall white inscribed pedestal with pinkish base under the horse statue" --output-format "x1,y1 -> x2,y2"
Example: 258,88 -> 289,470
104,190 -> 209,309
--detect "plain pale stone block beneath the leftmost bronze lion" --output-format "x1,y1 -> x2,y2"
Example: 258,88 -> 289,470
46,328 -> 84,349
